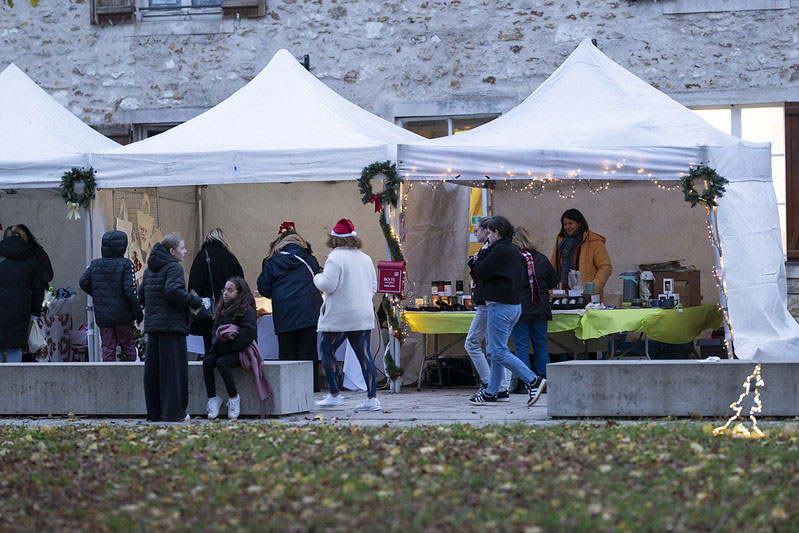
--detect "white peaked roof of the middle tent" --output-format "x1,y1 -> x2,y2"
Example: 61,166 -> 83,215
93,50 -> 421,187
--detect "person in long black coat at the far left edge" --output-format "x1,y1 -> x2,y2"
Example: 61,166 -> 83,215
0,228 -> 44,363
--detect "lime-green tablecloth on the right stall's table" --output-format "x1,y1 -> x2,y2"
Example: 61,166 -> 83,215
403,304 -> 721,344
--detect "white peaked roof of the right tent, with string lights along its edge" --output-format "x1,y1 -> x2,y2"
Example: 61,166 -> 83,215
398,40 -> 771,180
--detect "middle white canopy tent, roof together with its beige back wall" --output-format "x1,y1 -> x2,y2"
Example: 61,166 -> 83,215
92,50 -> 428,370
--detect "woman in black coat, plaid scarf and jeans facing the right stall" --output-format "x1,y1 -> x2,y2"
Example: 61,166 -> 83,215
511,227 -> 558,378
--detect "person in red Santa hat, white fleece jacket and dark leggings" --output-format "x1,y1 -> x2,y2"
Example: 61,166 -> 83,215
314,218 -> 380,411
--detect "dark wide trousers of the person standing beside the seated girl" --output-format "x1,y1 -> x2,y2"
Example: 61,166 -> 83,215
144,333 -> 189,422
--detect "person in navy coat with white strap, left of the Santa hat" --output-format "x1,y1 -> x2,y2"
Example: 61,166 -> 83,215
258,230 -> 322,392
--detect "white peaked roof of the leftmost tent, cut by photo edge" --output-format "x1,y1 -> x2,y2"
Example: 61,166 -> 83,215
0,63 -> 119,188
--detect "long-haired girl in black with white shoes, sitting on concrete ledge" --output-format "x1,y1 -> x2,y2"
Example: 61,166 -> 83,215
203,278 -> 258,420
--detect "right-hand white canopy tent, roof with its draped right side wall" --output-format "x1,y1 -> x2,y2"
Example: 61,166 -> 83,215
398,40 -> 799,359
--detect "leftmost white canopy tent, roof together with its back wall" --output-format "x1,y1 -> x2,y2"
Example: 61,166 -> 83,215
0,64 -> 119,362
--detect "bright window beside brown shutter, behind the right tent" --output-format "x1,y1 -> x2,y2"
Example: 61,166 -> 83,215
694,104 -> 788,253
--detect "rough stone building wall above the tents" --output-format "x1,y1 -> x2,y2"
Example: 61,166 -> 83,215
0,0 -> 799,126
